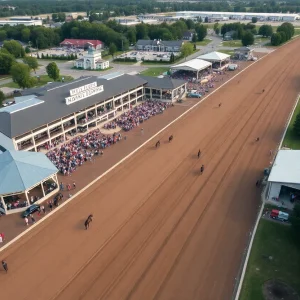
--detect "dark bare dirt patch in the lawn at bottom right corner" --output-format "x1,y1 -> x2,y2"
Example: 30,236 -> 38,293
263,279 -> 299,300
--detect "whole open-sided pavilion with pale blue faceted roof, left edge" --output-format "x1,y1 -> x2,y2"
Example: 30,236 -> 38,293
0,145 -> 59,214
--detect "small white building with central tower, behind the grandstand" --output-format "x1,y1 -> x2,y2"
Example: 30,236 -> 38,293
74,48 -> 109,70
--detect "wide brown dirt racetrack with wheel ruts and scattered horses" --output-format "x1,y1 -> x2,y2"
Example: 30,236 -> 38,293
0,39 -> 300,300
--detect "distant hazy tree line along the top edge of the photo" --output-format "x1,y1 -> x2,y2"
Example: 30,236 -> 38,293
4,0 -> 300,17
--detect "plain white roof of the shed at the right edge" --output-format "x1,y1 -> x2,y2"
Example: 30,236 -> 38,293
268,150 -> 300,184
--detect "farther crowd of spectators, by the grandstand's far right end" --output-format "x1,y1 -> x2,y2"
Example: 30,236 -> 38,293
104,100 -> 172,131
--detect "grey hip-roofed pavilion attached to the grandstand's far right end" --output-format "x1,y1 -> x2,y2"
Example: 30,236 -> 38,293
139,75 -> 187,102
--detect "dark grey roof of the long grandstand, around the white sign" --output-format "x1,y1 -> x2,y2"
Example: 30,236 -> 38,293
0,75 -> 146,138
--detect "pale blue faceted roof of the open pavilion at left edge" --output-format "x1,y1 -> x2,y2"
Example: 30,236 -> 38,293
0,150 -> 58,195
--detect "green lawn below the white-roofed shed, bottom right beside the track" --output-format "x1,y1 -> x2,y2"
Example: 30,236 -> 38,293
239,219 -> 300,300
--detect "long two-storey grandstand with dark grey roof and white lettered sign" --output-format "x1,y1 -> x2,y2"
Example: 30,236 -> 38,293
0,73 -> 186,152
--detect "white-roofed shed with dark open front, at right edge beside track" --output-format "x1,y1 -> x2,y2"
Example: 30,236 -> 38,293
266,150 -> 300,201
